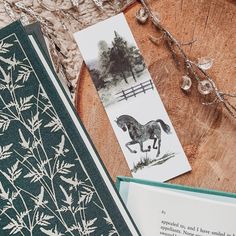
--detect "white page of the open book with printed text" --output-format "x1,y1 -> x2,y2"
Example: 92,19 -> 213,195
127,183 -> 236,236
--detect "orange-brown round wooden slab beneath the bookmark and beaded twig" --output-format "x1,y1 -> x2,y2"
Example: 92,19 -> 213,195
76,0 -> 236,192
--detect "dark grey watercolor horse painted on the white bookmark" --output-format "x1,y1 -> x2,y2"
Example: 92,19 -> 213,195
115,115 -> 171,157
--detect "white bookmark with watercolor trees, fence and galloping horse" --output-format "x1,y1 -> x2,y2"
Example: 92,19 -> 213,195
74,14 -> 191,181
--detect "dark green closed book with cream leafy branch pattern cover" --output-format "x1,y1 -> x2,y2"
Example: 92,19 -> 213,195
0,22 -> 139,236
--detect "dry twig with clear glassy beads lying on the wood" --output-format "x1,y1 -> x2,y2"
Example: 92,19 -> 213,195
136,0 -> 236,119
